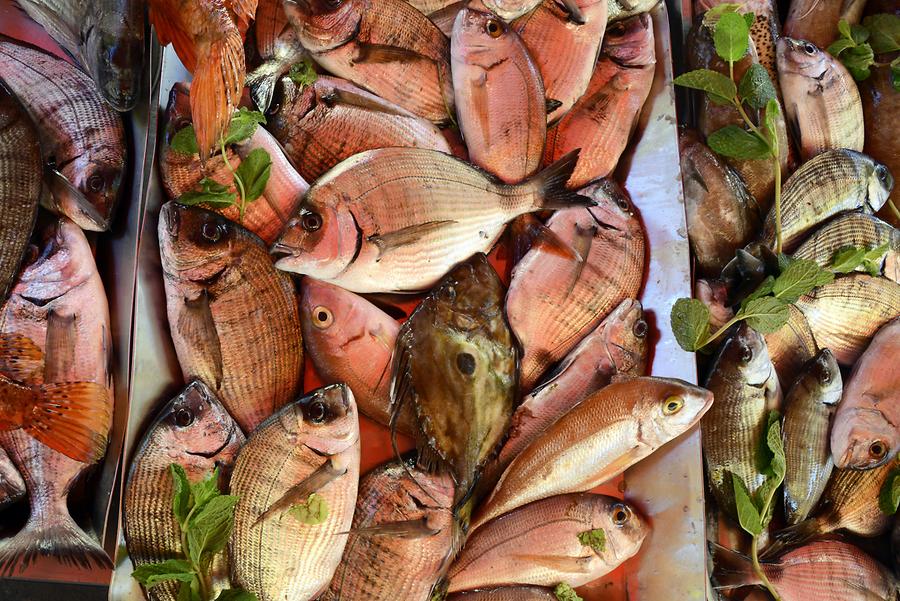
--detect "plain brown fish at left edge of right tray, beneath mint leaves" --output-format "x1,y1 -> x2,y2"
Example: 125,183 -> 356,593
679,130 -> 762,277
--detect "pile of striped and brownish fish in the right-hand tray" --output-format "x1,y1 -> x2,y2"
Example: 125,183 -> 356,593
681,0 -> 900,601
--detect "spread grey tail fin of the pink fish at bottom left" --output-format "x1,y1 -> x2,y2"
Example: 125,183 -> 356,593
0,506 -> 113,578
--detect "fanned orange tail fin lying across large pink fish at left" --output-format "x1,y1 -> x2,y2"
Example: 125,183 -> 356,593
22,382 -> 112,463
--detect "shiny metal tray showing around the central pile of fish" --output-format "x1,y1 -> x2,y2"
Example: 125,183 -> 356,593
110,3 -> 706,601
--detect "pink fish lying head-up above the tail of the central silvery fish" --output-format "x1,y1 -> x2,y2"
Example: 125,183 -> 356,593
450,8 -> 548,184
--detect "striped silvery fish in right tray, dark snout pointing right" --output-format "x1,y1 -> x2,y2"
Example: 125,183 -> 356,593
761,148 -> 894,252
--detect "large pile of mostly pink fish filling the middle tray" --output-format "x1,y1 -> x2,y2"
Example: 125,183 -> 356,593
123,0 -> 713,601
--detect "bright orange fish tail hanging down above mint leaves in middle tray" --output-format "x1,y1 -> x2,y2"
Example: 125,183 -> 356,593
191,30 -> 245,162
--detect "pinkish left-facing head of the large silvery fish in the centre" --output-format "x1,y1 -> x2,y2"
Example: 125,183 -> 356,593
271,200 -> 363,279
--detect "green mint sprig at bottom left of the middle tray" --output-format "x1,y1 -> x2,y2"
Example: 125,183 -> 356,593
131,463 -> 258,601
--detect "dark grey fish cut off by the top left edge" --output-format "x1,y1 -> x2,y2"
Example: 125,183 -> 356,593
18,0 -> 145,112
